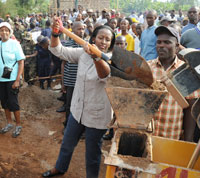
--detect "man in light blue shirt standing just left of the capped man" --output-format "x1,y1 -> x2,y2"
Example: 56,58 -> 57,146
140,10 -> 158,61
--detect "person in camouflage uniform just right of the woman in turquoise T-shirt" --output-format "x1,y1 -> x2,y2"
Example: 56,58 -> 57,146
22,32 -> 37,85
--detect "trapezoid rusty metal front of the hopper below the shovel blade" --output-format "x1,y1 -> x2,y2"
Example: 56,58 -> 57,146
106,87 -> 167,129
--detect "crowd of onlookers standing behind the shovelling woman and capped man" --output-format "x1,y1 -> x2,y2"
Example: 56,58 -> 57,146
0,5 -> 200,139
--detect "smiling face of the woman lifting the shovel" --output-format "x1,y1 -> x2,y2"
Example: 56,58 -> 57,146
94,28 -> 113,52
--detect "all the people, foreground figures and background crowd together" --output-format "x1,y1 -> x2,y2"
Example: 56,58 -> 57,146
0,5 -> 200,178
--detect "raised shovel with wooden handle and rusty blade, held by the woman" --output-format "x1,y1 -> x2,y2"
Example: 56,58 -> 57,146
60,28 -> 153,86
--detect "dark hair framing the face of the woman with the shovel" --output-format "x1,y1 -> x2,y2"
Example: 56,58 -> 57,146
89,25 -> 115,51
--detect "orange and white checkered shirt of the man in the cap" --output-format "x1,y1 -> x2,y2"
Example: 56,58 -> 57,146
148,57 -> 200,139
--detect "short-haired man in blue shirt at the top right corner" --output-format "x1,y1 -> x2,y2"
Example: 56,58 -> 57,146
181,7 -> 199,34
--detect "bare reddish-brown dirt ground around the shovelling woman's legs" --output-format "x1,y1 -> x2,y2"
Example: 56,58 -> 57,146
0,82 -> 111,178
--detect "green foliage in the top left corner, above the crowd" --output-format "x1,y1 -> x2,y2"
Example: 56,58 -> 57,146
0,0 -> 49,17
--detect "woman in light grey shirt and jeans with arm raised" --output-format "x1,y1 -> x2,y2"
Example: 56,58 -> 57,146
42,19 -> 115,178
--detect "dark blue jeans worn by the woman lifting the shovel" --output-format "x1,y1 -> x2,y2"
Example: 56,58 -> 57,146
55,114 -> 106,178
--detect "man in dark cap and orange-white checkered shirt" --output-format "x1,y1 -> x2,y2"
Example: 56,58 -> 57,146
148,26 -> 200,141
